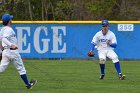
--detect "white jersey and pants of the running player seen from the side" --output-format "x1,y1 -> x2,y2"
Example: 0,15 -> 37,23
0,26 -> 26,75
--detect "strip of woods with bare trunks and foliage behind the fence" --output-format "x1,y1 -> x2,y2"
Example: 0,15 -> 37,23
0,0 -> 140,20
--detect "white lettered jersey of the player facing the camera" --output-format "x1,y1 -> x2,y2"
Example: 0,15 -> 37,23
91,30 -> 117,50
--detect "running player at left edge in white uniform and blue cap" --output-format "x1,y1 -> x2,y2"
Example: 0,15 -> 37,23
0,14 -> 37,89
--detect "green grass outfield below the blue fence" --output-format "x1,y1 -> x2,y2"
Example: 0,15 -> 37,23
0,60 -> 140,93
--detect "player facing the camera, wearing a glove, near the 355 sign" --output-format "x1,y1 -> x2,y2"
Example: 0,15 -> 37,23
88,20 -> 125,80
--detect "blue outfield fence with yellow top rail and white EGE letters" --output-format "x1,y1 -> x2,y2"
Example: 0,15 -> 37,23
0,21 -> 140,59
